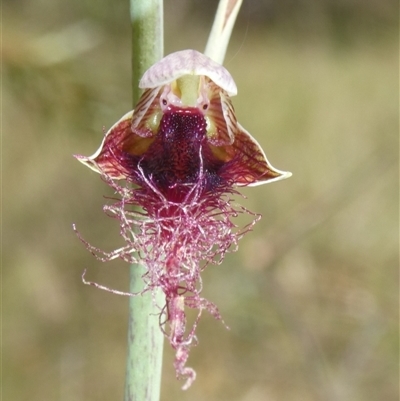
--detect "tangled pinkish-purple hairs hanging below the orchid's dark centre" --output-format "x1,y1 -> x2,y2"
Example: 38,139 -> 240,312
78,169 -> 260,389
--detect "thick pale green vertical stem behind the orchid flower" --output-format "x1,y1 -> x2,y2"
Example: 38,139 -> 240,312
124,0 -> 164,401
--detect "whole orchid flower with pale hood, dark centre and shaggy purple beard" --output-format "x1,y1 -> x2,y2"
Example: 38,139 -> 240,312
75,50 -> 291,388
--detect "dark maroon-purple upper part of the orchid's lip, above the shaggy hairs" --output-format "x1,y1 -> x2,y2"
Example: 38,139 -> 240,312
131,106 -> 224,201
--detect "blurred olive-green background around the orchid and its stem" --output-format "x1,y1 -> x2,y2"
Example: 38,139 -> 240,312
2,0 -> 399,401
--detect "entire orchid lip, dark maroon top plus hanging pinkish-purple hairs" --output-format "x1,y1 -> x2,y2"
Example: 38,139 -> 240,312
76,108 -> 260,388
